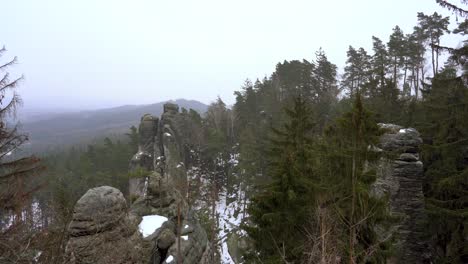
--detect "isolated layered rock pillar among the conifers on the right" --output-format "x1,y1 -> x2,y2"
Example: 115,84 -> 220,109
373,124 -> 428,263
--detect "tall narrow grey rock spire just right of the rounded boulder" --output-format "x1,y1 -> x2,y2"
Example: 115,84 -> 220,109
130,103 -> 213,264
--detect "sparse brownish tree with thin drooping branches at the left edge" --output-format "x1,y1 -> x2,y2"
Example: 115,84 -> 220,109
0,48 -> 44,263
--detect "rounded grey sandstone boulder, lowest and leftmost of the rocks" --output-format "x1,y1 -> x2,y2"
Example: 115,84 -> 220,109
66,186 -> 151,264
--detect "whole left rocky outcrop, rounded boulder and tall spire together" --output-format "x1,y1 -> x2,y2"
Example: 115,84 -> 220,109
67,104 -> 214,264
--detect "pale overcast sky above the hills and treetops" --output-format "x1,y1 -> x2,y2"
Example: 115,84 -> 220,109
0,0 -> 458,109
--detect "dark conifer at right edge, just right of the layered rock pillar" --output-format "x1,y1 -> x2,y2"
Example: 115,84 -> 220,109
421,69 -> 468,263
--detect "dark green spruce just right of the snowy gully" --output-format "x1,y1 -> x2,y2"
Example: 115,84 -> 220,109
246,97 -> 314,263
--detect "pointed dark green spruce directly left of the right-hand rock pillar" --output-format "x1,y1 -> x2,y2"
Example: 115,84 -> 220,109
321,94 -> 390,263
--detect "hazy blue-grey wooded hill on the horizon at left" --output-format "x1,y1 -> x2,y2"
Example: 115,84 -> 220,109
21,99 -> 208,152
